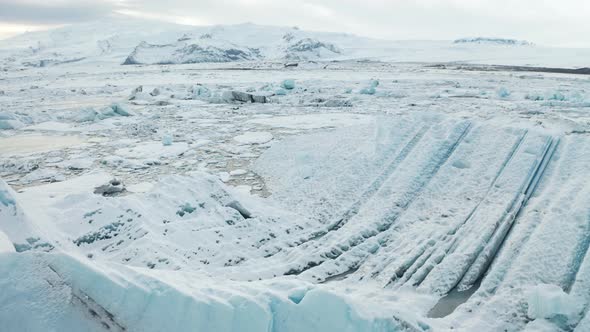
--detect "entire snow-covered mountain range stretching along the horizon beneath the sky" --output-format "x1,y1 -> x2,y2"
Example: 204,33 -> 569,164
0,16 -> 590,68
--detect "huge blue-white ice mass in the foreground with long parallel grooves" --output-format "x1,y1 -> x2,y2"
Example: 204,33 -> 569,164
0,114 -> 590,331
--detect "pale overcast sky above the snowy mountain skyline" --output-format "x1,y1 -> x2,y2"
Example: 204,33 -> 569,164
0,0 -> 590,47
